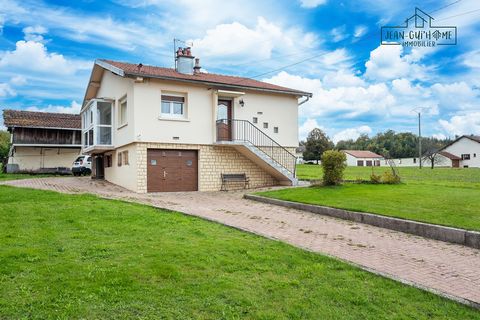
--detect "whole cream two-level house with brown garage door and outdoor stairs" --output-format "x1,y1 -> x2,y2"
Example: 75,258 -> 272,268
81,51 -> 311,193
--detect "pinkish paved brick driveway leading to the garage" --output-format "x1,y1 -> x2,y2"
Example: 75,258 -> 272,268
5,177 -> 480,307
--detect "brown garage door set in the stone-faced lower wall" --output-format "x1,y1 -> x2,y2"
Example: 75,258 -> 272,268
147,149 -> 198,192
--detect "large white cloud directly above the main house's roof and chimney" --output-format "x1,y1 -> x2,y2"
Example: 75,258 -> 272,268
192,17 -> 316,64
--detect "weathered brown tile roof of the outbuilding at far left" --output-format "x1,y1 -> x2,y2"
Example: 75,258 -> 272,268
3,110 -> 81,129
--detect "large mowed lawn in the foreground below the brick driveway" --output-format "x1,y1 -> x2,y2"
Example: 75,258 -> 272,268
0,186 -> 480,319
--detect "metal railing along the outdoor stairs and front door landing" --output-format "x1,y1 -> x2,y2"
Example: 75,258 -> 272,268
216,119 -> 297,177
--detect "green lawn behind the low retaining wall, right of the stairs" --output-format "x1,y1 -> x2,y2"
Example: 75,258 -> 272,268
261,165 -> 480,230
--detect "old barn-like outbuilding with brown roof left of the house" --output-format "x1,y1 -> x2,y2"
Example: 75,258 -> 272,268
3,110 -> 82,173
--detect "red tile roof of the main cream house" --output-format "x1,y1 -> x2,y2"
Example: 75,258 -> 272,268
98,59 -> 312,96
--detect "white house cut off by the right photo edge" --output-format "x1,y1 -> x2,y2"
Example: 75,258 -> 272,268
440,135 -> 480,168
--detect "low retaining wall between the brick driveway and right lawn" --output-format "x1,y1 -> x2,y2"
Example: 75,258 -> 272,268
245,194 -> 480,249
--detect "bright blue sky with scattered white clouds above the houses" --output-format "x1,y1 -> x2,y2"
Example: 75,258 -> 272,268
0,0 -> 480,141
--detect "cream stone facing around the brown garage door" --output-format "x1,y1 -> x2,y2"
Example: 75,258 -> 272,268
136,143 -> 278,193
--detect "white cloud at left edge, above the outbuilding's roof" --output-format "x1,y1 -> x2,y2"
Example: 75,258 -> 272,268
0,40 -> 91,74
